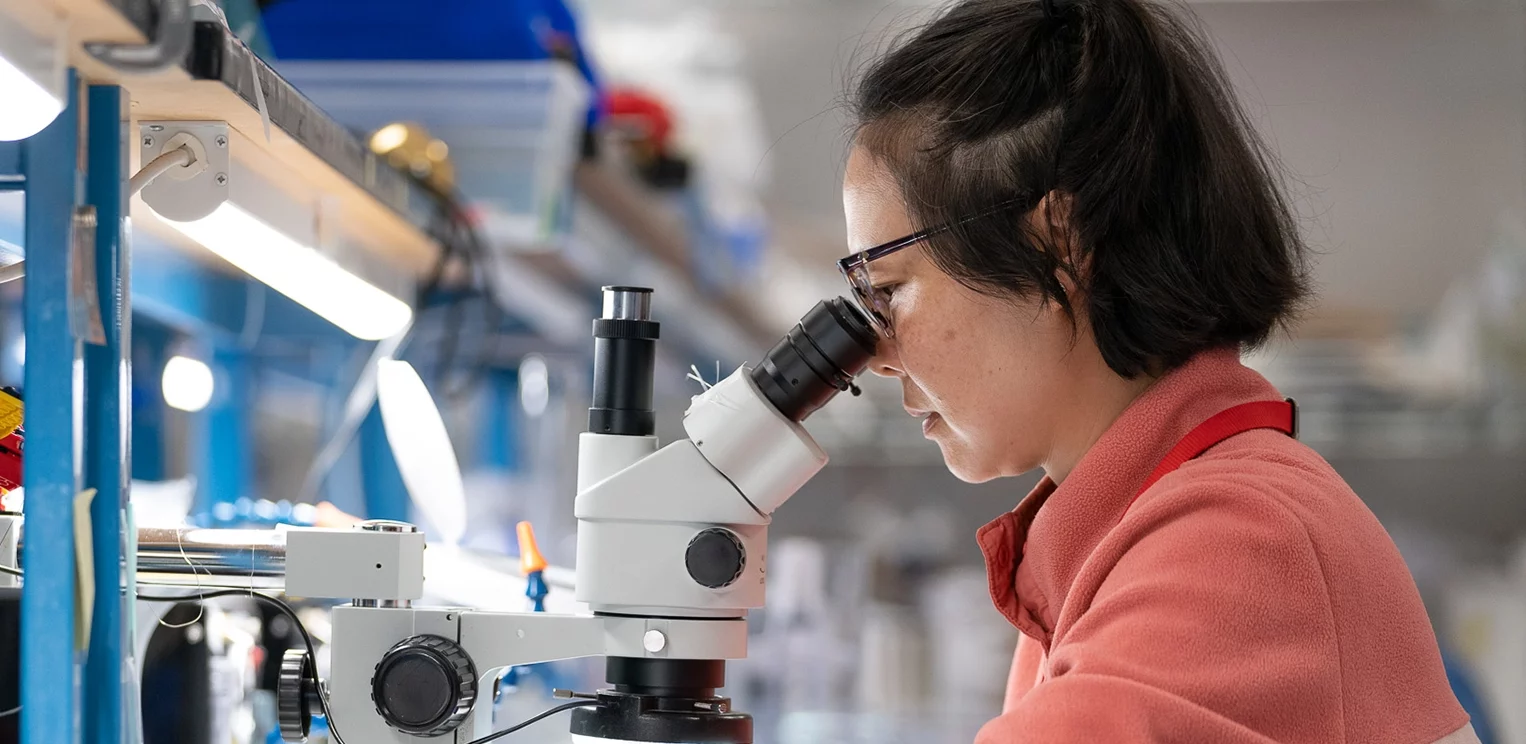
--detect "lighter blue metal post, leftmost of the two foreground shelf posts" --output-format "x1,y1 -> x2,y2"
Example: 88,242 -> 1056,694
21,73 -> 82,744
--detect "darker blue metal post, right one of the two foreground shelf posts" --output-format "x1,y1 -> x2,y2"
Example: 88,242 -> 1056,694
82,85 -> 133,744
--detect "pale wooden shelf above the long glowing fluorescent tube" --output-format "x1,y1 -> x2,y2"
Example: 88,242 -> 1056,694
0,0 -> 439,276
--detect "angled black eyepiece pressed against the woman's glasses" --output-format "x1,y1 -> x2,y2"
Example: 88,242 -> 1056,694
752,297 -> 879,421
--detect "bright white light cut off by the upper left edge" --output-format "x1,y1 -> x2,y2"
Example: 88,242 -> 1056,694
0,20 -> 64,142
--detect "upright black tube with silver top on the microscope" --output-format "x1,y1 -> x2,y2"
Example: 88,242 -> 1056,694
588,287 -> 661,436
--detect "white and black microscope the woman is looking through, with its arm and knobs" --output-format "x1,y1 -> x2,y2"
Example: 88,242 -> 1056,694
278,287 -> 877,744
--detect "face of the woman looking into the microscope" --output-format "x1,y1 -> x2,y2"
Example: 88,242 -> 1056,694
842,148 -> 1117,483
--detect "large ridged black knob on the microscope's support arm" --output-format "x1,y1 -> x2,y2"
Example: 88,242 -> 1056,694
371,636 -> 476,736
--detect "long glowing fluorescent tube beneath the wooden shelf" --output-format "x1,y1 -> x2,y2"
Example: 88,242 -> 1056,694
165,201 -> 414,342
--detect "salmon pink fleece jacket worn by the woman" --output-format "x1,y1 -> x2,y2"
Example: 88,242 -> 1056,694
975,349 -> 1477,744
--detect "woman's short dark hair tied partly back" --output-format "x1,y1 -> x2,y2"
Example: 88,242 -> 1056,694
850,0 -> 1308,378
